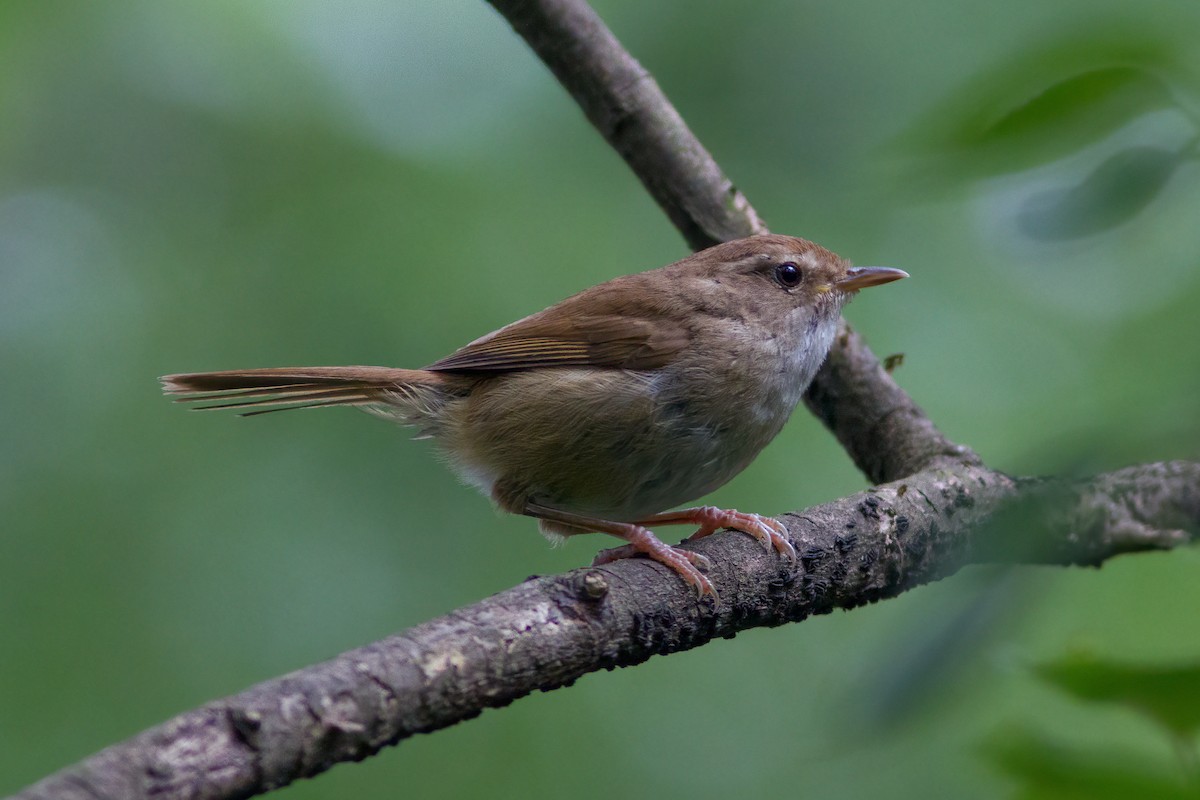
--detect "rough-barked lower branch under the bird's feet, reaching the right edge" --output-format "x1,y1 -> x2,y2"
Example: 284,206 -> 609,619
17,462 -> 1200,800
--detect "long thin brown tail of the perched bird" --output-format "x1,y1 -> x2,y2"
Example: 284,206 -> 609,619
160,367 -> 448,425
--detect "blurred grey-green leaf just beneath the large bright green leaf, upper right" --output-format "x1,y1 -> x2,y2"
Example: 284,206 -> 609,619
1016,146 -> 1182,241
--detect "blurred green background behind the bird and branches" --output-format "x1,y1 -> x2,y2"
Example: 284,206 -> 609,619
0,0 -> 1200,800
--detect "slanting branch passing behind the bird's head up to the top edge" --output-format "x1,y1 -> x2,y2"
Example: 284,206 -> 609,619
488,0 -> 980,483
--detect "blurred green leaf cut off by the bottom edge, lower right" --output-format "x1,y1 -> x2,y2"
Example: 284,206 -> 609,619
984,728 -> 1195,800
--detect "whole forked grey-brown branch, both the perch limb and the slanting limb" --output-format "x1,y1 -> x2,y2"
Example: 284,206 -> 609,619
9,0 -> 1200,800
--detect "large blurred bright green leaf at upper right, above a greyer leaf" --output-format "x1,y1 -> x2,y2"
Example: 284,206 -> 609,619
900,31 -> 1180,180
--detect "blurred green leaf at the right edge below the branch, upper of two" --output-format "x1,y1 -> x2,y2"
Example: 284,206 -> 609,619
1036,655 -> 1200,736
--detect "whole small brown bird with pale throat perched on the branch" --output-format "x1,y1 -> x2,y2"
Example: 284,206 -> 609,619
162,235 -> 907,597
